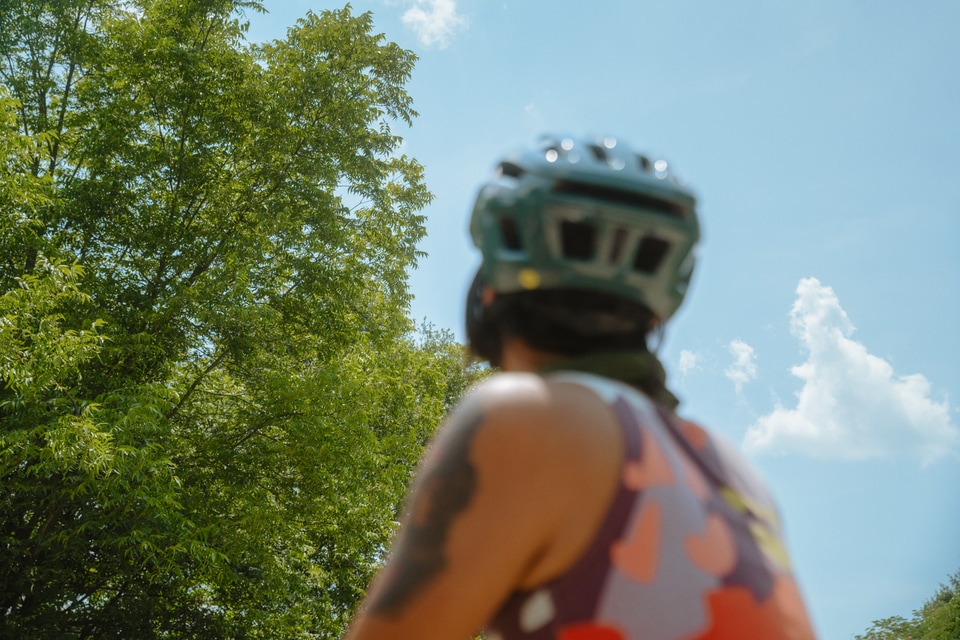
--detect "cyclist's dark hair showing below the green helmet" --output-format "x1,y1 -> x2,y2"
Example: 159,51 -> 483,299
467,272 -> 653,366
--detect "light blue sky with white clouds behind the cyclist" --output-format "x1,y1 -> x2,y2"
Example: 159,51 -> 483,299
250,0 -> 960,640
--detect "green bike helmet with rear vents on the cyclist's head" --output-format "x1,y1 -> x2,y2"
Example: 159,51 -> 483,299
470,137 -> 700,323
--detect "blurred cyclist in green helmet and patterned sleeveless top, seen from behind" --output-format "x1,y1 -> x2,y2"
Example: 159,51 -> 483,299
347,137 -> 814,640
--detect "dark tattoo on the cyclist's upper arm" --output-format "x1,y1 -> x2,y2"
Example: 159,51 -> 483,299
369,412 -> 483,617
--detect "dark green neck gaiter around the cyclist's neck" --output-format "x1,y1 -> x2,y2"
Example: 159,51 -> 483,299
540,351 -> 680,410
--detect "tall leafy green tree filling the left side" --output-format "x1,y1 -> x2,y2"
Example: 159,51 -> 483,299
0,0 -> 468,638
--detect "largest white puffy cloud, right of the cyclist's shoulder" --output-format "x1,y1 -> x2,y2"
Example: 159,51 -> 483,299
744,278 -> 960,463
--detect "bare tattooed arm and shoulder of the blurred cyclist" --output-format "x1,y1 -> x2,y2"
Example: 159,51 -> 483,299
347,375 -> 620,640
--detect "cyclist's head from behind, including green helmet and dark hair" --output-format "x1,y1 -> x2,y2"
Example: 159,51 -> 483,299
467,132 -> 700,365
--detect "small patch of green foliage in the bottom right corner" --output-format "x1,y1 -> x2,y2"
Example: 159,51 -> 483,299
856,571 -> 960,640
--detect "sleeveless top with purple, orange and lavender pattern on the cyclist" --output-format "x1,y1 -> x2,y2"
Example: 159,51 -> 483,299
486,372 -> 814,640
